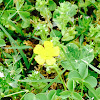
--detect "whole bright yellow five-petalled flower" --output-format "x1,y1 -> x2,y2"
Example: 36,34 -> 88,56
34,41 -> 60,65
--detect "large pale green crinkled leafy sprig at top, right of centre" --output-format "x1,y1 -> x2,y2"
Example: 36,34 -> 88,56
53,2 -> 77,35
